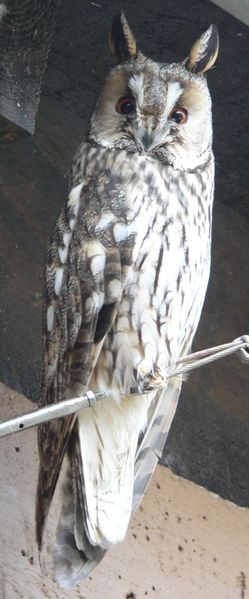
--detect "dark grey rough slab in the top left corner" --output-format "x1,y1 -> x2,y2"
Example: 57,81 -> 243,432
0,0 -> 60,133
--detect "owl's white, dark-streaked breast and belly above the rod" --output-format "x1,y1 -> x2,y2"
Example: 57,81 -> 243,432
70,143 -> 214,384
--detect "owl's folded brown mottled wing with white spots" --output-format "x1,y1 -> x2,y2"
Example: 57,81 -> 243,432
36,174 -> 131,547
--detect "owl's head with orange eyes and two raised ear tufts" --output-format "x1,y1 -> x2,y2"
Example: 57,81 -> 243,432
89,14 -> 219,170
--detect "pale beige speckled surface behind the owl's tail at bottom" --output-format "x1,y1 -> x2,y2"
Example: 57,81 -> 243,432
0,384 -> 249,599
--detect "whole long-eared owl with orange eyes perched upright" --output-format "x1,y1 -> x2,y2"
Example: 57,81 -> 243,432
37,16 -> 217,585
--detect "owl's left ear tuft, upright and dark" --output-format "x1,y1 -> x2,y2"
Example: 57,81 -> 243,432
110,13 -> 137,63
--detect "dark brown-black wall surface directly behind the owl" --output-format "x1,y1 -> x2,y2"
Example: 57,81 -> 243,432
0,0 -> 249,506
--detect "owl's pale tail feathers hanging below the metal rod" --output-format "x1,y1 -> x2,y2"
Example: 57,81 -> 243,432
47,378 -> 181,588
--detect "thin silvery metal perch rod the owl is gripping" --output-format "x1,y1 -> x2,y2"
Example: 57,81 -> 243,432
0,335 -> 249,438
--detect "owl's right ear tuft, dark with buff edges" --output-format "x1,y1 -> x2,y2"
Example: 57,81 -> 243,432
185,25 -> 219,75
